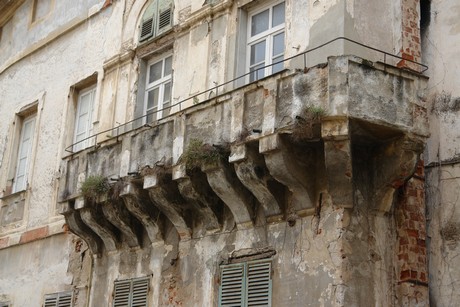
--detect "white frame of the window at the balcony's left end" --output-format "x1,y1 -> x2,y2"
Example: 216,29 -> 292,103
73,85 -> 96,152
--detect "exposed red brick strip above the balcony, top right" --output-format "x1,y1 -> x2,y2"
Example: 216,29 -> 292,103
398,0 -> 422,71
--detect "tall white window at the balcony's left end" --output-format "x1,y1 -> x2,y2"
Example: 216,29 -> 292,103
73,86 -> 96,152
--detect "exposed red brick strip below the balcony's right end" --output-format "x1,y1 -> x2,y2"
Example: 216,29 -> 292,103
395,161 -> 428,301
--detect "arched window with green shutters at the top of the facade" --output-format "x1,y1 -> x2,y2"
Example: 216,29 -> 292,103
139,0 -> 173,42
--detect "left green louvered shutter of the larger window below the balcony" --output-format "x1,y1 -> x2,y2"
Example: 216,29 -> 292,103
219,264 -> 244,307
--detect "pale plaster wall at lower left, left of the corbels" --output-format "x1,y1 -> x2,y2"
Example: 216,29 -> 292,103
0,234 -> 91,307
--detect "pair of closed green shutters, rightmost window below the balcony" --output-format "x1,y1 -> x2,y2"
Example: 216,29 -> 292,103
219,260 -> 272,307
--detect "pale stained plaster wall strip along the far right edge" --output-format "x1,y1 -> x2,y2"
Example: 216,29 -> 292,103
421,0 -> 460,306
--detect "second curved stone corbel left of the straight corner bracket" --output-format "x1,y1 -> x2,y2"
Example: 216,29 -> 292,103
230,144 -> 283,222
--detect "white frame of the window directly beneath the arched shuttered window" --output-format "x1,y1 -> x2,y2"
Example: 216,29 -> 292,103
143,53 -> 173,124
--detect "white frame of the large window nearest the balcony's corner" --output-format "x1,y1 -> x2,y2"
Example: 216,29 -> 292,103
246,1 -> 286,82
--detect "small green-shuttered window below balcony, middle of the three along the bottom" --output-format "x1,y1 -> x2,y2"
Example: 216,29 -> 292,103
113,278 -> 150,307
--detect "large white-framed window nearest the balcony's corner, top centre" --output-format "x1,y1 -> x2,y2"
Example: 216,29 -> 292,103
247,2 -> 285,82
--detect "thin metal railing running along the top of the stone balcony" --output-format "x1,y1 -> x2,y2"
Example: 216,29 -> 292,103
65,37 -> 428,153
